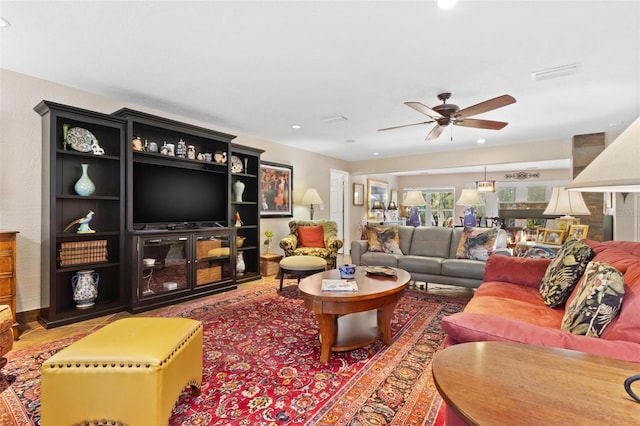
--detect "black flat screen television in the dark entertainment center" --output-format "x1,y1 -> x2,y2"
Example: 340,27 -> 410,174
132,163 -> 228,229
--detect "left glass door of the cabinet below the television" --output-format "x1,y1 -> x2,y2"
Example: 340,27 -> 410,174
138,235 -> 189,298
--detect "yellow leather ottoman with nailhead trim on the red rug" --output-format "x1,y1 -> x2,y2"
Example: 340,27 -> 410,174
40,318 -> 202,426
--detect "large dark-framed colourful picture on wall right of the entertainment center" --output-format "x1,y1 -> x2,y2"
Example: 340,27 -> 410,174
260,161 -> 293,218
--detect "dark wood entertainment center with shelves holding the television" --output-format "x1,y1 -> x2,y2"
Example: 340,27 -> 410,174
35,101 -> 263,328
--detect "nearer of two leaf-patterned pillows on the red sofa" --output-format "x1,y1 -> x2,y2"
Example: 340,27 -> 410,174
561,262 -> 624,337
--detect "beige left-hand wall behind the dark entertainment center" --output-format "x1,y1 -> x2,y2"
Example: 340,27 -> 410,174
0,69 -> 349,312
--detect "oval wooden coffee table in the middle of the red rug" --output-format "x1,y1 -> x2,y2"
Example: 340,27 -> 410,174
298,266 -> 411,363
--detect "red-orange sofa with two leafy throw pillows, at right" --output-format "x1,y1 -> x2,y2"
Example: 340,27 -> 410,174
442,240 -> 640,362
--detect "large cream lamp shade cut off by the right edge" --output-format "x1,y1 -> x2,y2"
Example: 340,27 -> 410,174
566,117 -> 640,192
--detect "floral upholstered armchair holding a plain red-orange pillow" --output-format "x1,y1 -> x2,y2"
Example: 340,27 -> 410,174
280,220 -> 343,269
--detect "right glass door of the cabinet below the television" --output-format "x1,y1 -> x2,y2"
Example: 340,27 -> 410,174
195,233 -> 233,286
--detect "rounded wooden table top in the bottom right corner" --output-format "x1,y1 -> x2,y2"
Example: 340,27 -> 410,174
432,342 -> 640,425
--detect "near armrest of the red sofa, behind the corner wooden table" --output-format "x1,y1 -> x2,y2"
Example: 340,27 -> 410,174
442,312 -> 640,362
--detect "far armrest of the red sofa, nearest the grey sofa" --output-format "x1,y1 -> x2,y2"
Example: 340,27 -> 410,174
483,256 -> 551,288
